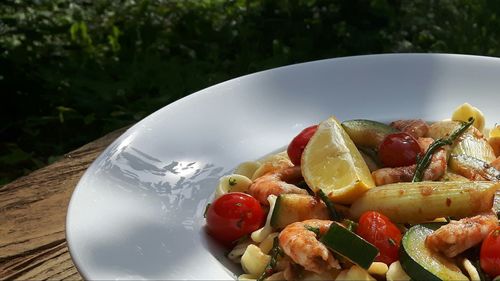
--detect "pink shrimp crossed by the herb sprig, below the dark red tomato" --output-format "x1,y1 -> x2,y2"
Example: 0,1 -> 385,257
372,138 -> 447,185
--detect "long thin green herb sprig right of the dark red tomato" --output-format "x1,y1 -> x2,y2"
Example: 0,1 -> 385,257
412,117 -> 474,182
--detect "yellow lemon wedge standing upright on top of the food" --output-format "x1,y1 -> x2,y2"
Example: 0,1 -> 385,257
301,116 -> 375,204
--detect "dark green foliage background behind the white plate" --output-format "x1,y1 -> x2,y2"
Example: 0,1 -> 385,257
0,0 -> 500,185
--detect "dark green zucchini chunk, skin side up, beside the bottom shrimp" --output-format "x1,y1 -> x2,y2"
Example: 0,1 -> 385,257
320,222 -> 378,269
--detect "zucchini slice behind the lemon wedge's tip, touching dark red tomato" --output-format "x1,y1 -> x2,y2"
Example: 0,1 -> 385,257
342,119 -> 398,150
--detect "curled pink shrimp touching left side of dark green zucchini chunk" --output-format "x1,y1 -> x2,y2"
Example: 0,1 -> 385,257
279,219 -> 340,274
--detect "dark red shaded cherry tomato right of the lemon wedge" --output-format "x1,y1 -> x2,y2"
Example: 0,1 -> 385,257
378,133 -> 422,167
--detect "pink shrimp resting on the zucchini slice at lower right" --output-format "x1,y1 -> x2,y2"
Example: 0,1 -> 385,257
425,212 -> 498,258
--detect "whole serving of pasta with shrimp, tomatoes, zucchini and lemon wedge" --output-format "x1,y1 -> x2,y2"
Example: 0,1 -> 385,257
205,104 -> 500,280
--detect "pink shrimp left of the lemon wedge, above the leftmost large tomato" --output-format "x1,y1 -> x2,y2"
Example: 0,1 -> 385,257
248,166 -> 308,205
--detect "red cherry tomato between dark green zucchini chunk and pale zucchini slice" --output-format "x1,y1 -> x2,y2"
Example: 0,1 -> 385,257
356,211 -> 402,265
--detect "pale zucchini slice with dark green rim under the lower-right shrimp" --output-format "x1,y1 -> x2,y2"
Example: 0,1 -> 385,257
399,224 -> 468,280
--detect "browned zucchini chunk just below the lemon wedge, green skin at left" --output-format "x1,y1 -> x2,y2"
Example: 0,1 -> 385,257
271,194 -> 329,229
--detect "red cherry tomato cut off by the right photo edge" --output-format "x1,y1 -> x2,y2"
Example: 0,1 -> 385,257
479,226 -> 500,278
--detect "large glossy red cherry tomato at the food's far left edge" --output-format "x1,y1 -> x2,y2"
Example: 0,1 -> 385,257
206,192 -> 265,246
